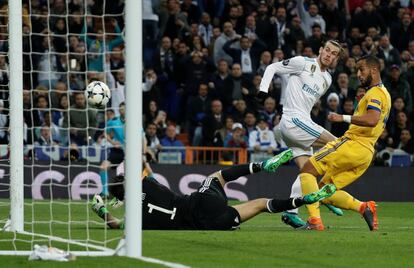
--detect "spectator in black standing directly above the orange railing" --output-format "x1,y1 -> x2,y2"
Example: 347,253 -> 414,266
201,100 -> 224,146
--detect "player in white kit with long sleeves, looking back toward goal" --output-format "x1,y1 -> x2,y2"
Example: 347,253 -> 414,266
259,40 -> 342,229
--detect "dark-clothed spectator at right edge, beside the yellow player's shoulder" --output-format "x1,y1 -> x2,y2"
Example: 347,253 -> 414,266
384,65 -> 413,111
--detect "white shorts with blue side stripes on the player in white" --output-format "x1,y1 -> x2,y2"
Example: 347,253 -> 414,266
279,114 -> 325,157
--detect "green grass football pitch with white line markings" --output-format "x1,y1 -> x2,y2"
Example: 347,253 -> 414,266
0,200 -> 414,268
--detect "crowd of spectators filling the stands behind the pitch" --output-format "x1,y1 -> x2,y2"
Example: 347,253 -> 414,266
0,0 -> 414,165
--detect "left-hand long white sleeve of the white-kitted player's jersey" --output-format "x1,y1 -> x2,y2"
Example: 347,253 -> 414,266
260,56 -> 305,93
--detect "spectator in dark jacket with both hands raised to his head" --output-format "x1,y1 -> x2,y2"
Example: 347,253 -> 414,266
223,36 -> 266,75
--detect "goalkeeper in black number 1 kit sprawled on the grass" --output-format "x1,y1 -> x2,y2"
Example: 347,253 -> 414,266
92,150 -> 336,230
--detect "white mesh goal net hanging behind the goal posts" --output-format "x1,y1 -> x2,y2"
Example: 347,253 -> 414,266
0,0 -> 136,255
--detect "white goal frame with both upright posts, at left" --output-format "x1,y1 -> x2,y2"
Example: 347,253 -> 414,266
0,0 -> 145,260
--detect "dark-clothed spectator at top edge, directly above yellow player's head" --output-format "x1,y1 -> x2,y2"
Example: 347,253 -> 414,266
351,0 -> 386,34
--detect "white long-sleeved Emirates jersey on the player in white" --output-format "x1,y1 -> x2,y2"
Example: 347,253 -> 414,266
260,56 -> 332,117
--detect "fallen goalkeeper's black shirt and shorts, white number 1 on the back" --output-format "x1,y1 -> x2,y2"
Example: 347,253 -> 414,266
142,178 -> 240,230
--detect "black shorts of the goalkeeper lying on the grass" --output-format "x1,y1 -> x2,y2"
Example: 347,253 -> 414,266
194,177 -> 241,230
